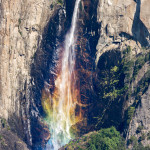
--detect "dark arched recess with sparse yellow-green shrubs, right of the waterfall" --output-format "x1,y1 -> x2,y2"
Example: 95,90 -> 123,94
88,50 -> 125,130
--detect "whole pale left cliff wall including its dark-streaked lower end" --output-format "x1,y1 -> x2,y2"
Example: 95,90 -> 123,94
0,0 -> 57,148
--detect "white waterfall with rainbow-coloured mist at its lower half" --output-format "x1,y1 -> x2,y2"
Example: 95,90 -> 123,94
42,0 -> 82,150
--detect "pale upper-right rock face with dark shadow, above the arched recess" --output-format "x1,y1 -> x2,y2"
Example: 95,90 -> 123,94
96,0 -> 150,62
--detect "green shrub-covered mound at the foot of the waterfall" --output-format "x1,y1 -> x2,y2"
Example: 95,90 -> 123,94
60,127 -> 150,150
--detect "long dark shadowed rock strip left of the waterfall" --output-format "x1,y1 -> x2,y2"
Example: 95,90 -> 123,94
30,8 -> 67,149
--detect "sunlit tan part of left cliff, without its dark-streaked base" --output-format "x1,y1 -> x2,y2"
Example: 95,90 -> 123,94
0,0 -> 51,118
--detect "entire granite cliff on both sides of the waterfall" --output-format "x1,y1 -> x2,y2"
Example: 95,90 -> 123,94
0,0 -> 150,150
